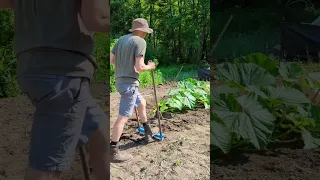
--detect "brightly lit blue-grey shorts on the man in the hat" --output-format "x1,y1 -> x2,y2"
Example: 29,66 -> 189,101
116,84 -> 142,117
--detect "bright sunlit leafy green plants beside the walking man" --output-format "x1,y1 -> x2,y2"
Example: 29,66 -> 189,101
154,78 -> 210,113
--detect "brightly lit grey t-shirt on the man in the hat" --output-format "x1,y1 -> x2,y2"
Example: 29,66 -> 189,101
112,33 -> 146,86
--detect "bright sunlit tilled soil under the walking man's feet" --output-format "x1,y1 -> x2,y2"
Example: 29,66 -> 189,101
110,84 -> 210,180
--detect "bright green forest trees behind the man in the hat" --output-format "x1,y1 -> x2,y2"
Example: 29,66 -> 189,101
111,0 -> 210,65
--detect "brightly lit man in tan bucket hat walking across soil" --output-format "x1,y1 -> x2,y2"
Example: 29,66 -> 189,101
110,18 -> 155,163
